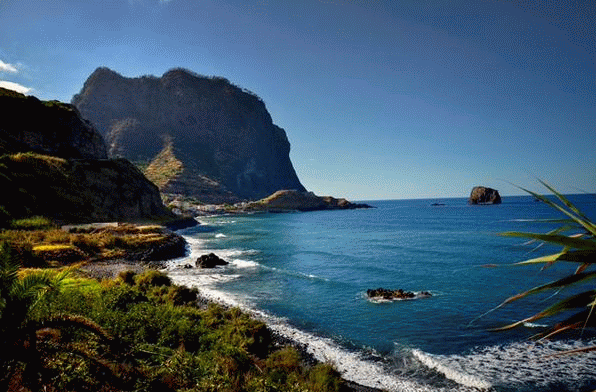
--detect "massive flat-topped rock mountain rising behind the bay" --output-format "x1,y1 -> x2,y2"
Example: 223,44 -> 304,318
72,68 -> 305,202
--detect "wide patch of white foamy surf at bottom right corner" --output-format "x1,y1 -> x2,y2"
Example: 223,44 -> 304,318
413,341 -> 596,389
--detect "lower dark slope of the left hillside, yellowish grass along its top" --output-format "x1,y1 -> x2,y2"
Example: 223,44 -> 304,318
0,152 -> 173,222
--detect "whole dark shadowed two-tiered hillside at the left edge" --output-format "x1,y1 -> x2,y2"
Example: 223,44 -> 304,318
0,88 -> 173,223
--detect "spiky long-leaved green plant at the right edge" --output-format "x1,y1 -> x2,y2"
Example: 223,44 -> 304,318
498,181 -> 596,351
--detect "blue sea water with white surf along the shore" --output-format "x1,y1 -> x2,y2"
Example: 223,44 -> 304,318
168,195 -> 596,391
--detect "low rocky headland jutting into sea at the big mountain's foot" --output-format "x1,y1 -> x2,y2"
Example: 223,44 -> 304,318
244,190 -> 370,212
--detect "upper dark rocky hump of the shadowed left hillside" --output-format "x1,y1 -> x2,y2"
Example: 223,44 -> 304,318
0,88 -> 107,159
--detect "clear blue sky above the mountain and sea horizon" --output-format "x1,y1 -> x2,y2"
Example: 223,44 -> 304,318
0,0 -> 596,200
